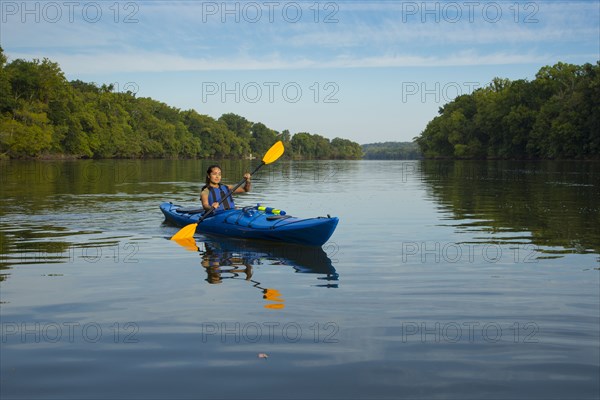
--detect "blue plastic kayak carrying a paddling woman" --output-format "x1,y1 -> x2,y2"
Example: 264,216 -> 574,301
160,203 -> 339,246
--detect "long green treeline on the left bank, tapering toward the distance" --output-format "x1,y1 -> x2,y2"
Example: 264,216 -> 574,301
0,48 -> 362,159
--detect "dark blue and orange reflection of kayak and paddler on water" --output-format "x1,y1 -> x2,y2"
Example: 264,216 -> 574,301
197,238 -> 339,309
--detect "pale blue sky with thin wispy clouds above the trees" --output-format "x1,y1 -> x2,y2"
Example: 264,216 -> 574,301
0,0 -> 600,144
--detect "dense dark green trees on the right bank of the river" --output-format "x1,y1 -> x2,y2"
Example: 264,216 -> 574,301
416,62 -> 600,159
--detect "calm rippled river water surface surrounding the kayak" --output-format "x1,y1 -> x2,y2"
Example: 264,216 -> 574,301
0,161 -> 600,399
